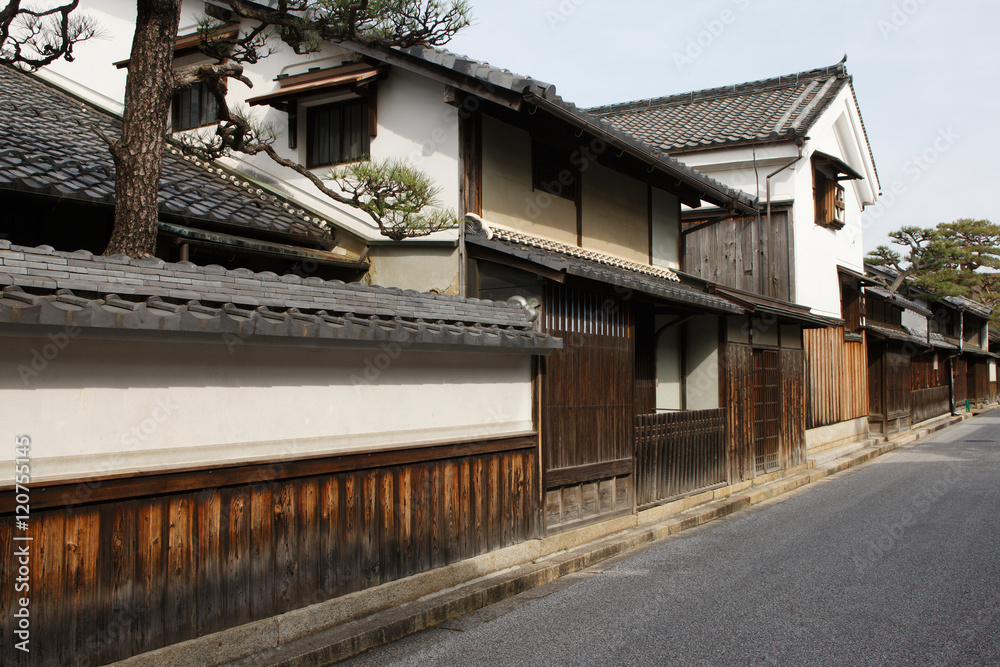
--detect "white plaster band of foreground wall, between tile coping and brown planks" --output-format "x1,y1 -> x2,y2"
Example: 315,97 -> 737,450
0,337 -> 532,484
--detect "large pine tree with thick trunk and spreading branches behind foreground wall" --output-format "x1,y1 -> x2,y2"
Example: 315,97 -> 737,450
0,0 -> 470,257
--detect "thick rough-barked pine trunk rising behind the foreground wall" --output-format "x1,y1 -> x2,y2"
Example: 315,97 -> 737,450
104,0 -> 181,258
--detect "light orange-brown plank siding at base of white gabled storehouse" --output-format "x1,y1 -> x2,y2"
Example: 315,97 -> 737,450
803,327 -> 868,428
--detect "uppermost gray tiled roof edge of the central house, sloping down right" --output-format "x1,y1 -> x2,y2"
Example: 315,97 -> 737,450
345,44 -> 757,212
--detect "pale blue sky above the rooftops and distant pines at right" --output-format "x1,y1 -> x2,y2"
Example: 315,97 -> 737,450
448,0 -> 1000,250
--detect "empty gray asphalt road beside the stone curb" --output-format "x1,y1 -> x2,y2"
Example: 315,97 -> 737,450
342,411 -> 1000,667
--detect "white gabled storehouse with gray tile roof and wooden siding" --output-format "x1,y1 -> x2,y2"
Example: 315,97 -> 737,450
591,59 -> 879,449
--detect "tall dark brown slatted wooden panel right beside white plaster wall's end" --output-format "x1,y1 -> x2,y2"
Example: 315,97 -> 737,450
539,283 -> 636,529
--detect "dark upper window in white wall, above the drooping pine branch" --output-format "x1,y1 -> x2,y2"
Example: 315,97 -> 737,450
306,100 -> 371,169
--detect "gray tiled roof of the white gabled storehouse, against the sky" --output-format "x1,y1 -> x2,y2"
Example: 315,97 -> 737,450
590,63 -> 851,153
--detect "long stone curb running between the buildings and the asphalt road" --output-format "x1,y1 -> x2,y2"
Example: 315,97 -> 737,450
116,412 -> 992,667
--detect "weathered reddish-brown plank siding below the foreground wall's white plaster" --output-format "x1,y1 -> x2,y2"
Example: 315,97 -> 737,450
0,438 -> 541,665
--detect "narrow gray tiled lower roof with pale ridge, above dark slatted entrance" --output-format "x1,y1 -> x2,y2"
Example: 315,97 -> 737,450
466,217 -> 744,315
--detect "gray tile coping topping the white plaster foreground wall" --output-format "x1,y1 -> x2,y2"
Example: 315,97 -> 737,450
0,241 -> 562,353
